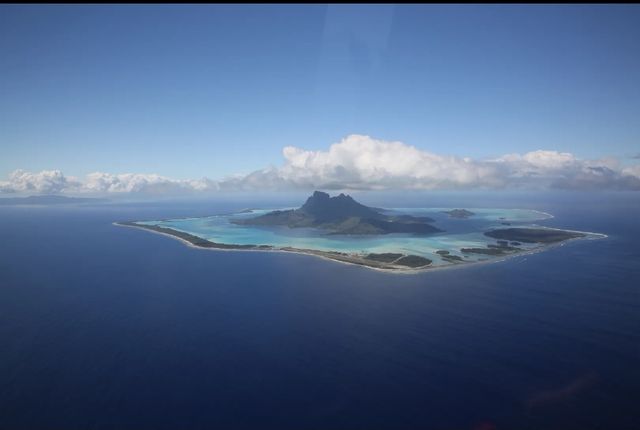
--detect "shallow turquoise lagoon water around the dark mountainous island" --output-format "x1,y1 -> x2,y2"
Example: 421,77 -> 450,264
138,208 -> 600,266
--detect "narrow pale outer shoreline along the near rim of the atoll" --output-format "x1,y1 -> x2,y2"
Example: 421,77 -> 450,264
112,222 -> 608,275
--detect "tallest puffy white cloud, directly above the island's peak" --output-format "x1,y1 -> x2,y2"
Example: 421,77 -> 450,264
264,135 -> 503,189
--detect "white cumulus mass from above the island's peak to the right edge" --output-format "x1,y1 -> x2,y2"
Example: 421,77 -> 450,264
221,135 -> 640,190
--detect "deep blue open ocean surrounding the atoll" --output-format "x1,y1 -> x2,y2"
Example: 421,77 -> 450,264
0,193 -> 640,430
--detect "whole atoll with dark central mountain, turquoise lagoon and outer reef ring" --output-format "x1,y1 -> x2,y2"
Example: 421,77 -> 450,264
115,191 -> 604,273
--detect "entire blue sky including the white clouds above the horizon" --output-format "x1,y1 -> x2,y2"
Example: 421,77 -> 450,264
0,5 -> 640,193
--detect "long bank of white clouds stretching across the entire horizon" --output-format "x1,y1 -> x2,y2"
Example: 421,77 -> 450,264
0,135 -> 640,194
